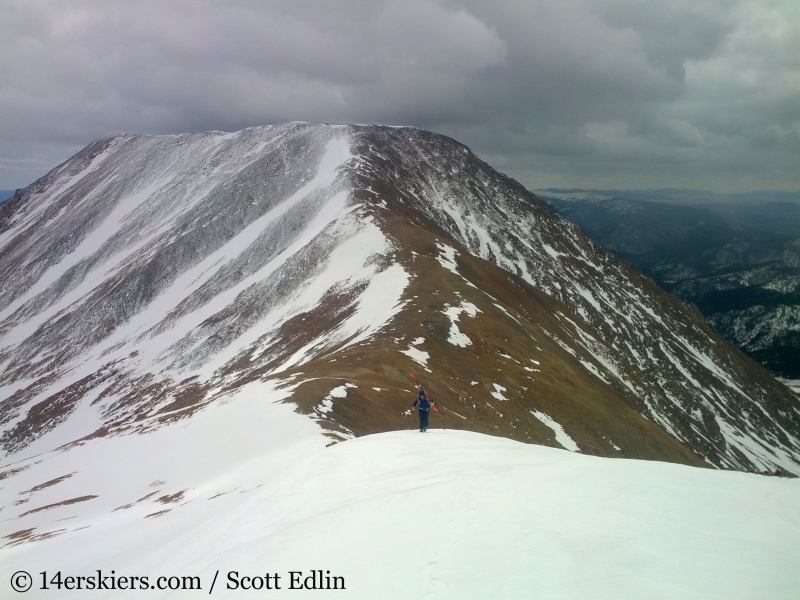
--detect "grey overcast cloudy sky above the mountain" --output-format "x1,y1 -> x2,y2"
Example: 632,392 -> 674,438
0,0 -> 800,191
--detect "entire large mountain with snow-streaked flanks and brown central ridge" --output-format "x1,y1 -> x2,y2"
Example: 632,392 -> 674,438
0,123 -> 800,482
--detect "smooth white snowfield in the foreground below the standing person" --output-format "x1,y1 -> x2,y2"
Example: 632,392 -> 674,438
0,382 -> 800,600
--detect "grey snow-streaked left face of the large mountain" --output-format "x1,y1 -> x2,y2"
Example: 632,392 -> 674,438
0,123 -> 408,450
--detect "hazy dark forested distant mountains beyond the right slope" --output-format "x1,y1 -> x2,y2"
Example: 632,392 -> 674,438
536,189 -> 800,380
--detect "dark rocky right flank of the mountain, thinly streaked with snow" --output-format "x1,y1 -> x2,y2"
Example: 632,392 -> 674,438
357,129 -> 800,472
